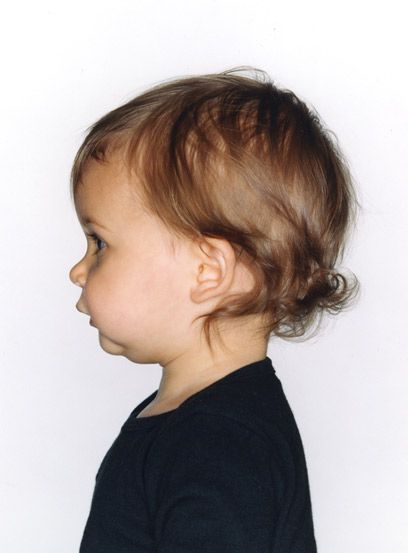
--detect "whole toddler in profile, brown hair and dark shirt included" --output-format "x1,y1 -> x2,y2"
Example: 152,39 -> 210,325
70,68 -> 358,553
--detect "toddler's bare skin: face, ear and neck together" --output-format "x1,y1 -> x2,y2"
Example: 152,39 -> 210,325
69,149 -> 267,416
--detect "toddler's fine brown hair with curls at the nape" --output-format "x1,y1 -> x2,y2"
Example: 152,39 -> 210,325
71,66 -> 360,348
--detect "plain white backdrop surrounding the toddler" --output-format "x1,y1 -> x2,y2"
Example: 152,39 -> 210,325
0,0 -> 408,553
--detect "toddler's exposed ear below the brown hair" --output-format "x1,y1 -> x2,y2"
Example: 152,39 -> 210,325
190,236 -> 236,303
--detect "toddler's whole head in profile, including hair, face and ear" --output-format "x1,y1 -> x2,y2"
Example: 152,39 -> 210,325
70,64 -> 359,364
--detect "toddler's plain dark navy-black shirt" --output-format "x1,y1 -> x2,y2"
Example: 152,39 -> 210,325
80,357 -> 316,553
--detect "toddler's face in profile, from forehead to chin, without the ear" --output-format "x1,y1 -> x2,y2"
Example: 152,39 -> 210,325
70,152 -> 199,364
